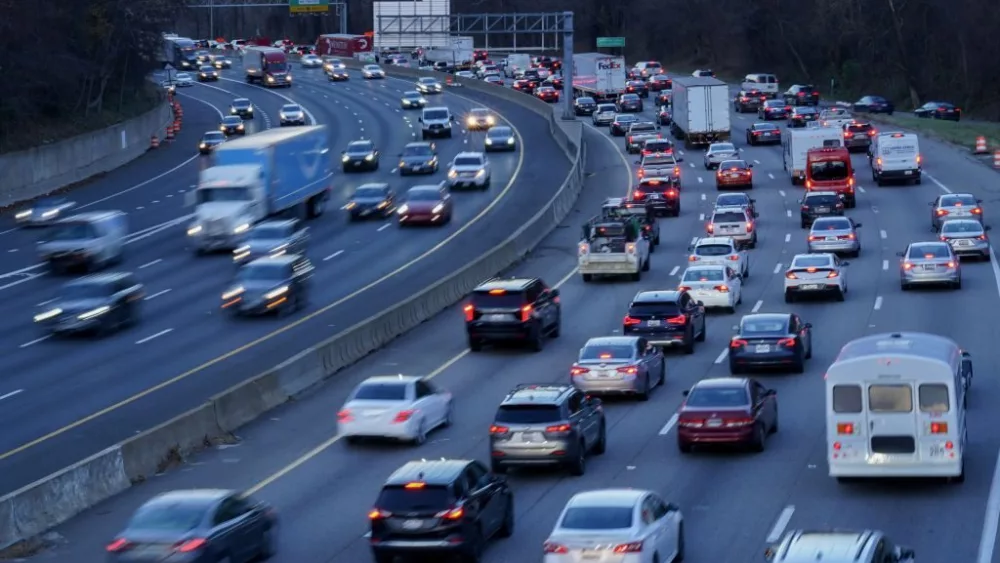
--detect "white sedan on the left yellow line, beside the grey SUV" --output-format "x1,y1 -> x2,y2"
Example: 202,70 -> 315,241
337,375 -> 452,445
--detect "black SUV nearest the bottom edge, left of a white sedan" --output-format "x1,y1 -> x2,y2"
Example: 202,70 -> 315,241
368,459 -> 514,563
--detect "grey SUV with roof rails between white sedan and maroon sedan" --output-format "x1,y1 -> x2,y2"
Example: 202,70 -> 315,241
490,383 -> 607,475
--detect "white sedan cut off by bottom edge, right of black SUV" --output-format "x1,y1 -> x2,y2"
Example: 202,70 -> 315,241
543,489 -> 684,563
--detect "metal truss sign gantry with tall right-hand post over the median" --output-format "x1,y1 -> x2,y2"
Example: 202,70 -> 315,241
375,10 -> 576,121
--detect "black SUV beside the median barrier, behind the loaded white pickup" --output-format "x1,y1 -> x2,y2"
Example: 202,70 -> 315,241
464,278 -> 562,352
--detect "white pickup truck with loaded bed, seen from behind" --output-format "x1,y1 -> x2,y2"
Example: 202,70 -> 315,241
577,220 -> 650,282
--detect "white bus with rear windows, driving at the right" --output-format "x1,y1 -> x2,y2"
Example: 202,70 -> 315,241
825,332 -> 972,482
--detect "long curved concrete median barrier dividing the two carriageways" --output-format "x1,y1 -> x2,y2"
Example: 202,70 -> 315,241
0,70 -> 586,555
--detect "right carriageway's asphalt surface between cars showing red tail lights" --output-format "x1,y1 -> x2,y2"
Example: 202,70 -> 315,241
39,72 -> 1000,563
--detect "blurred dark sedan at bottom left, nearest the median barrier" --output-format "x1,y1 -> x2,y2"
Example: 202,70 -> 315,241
105,490 -> 278,563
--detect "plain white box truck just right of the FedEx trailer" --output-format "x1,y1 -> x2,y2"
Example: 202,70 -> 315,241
670,76 -> 732,148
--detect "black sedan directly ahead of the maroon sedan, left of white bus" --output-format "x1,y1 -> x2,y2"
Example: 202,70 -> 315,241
729,313 -> 812,375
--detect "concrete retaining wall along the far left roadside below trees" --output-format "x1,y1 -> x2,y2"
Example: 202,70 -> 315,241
0,102 -> 173,207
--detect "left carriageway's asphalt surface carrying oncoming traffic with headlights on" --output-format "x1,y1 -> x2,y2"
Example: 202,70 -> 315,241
0,68 -> 568,492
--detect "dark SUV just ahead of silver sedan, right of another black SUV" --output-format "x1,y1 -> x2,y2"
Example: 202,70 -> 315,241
622,290 -> 705,354
